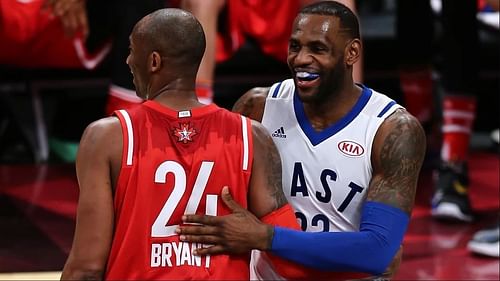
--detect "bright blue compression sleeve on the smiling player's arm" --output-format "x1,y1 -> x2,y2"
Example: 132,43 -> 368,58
271,201 -> 410,275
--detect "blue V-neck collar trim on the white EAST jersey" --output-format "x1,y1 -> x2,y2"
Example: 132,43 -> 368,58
293,85 -> 372,145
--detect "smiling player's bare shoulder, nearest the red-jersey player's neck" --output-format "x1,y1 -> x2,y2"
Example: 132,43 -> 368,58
233,87 -> 270,121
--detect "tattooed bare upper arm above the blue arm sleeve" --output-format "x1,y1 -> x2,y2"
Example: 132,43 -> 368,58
367,112 -> 425,213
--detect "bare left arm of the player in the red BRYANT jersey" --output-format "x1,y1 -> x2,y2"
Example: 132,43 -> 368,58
61,117 -> 122,280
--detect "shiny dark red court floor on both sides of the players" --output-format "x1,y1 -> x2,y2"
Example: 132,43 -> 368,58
0,152 -> 500,280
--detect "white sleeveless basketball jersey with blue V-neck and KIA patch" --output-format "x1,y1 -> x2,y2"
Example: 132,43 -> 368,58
251,79 -> 401,279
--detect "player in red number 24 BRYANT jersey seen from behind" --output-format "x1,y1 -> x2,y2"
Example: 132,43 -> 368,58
61,9 -> 297,280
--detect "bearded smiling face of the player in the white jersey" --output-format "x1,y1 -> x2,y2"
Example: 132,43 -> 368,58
288,14 -> 351,102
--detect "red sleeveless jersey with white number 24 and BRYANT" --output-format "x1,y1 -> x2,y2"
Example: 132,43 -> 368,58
106,101 -> 253,280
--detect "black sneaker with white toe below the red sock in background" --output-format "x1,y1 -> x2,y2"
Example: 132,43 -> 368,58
431,163 -> 474,222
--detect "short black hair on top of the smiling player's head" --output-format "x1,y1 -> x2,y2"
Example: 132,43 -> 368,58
299,1 -> 361,39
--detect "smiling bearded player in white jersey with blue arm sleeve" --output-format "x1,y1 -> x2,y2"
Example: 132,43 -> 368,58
178,1 -> 425,279
